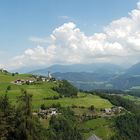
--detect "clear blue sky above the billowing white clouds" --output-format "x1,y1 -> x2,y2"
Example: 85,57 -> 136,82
0,0 -> 138,70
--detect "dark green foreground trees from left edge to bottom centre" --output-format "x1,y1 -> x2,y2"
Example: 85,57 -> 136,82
0,90 -> 83,140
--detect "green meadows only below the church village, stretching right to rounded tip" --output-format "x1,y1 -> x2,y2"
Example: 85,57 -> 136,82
0,83 -> 112,108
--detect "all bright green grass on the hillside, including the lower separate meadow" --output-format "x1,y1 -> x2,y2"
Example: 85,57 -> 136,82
0,73 -> 113,140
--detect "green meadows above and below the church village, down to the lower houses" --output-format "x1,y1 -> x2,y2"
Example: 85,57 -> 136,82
0,74 -> 112,108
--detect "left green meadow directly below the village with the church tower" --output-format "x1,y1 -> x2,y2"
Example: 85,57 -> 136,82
0,83 -> 58,104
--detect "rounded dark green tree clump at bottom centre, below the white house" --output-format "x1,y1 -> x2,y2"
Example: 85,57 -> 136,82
48,116 -> 83,140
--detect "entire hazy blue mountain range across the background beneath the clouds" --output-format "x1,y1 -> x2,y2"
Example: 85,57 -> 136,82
29,63 -> 140,90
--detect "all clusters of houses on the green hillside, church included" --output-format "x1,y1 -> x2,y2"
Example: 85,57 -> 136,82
0,69 -> 124,119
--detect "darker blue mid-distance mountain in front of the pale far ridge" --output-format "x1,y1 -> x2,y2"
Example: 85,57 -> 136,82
53,72 -> 115,90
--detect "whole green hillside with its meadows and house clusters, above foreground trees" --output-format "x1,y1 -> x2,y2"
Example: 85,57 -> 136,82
0,71 -> 140,140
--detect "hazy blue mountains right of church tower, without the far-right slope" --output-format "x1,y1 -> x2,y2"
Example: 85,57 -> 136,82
29,63 -> 124,90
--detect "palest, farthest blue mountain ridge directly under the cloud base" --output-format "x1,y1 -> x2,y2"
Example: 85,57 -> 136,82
29,63 -> 123,75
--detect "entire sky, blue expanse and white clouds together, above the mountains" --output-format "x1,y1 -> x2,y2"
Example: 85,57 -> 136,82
0,0 -> 140,70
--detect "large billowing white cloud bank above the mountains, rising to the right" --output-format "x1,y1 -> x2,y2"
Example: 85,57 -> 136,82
4,2 -> 140,68
